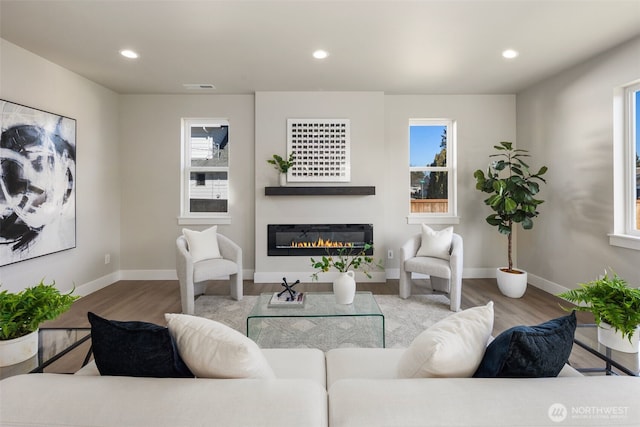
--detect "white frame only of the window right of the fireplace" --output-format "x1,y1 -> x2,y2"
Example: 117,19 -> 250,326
407,118 -> 460,224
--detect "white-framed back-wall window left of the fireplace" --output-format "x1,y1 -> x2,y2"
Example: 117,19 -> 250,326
181,119 -> 229,223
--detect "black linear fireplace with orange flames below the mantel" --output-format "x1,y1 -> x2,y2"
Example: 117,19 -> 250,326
267,224 -> 373,256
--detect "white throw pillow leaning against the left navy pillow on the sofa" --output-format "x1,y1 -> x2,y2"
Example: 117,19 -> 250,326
164,313 -> 275,378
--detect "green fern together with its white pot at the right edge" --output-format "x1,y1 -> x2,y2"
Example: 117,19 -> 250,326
558,270 -> 640,353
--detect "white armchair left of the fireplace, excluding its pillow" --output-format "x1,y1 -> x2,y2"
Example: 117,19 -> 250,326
176,234 -> 243,314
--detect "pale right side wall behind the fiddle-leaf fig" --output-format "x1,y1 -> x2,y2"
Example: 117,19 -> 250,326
517,38 -> 640,290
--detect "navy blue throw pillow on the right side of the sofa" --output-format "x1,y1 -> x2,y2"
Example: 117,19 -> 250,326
473,312 -> 576,378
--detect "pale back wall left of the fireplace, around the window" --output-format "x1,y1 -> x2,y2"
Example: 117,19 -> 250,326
120,95 -> 254,278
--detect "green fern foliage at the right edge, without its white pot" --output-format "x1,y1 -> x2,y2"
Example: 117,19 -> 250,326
558,271 -> 640,341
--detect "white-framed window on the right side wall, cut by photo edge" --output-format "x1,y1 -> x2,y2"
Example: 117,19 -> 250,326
610,81 -> 640,250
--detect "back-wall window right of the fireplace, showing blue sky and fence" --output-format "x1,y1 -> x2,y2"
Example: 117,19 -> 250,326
409,119 -> 456,223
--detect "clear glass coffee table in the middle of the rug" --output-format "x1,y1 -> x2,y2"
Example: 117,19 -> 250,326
247,292 -> 385,351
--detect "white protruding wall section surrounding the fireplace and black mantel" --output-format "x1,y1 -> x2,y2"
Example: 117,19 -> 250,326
255,92 -> 388,282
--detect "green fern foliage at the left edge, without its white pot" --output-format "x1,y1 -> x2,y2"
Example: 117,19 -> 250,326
0,279 -> 80,340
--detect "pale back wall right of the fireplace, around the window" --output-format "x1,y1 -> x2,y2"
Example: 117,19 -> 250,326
384,95 -> 516,277
